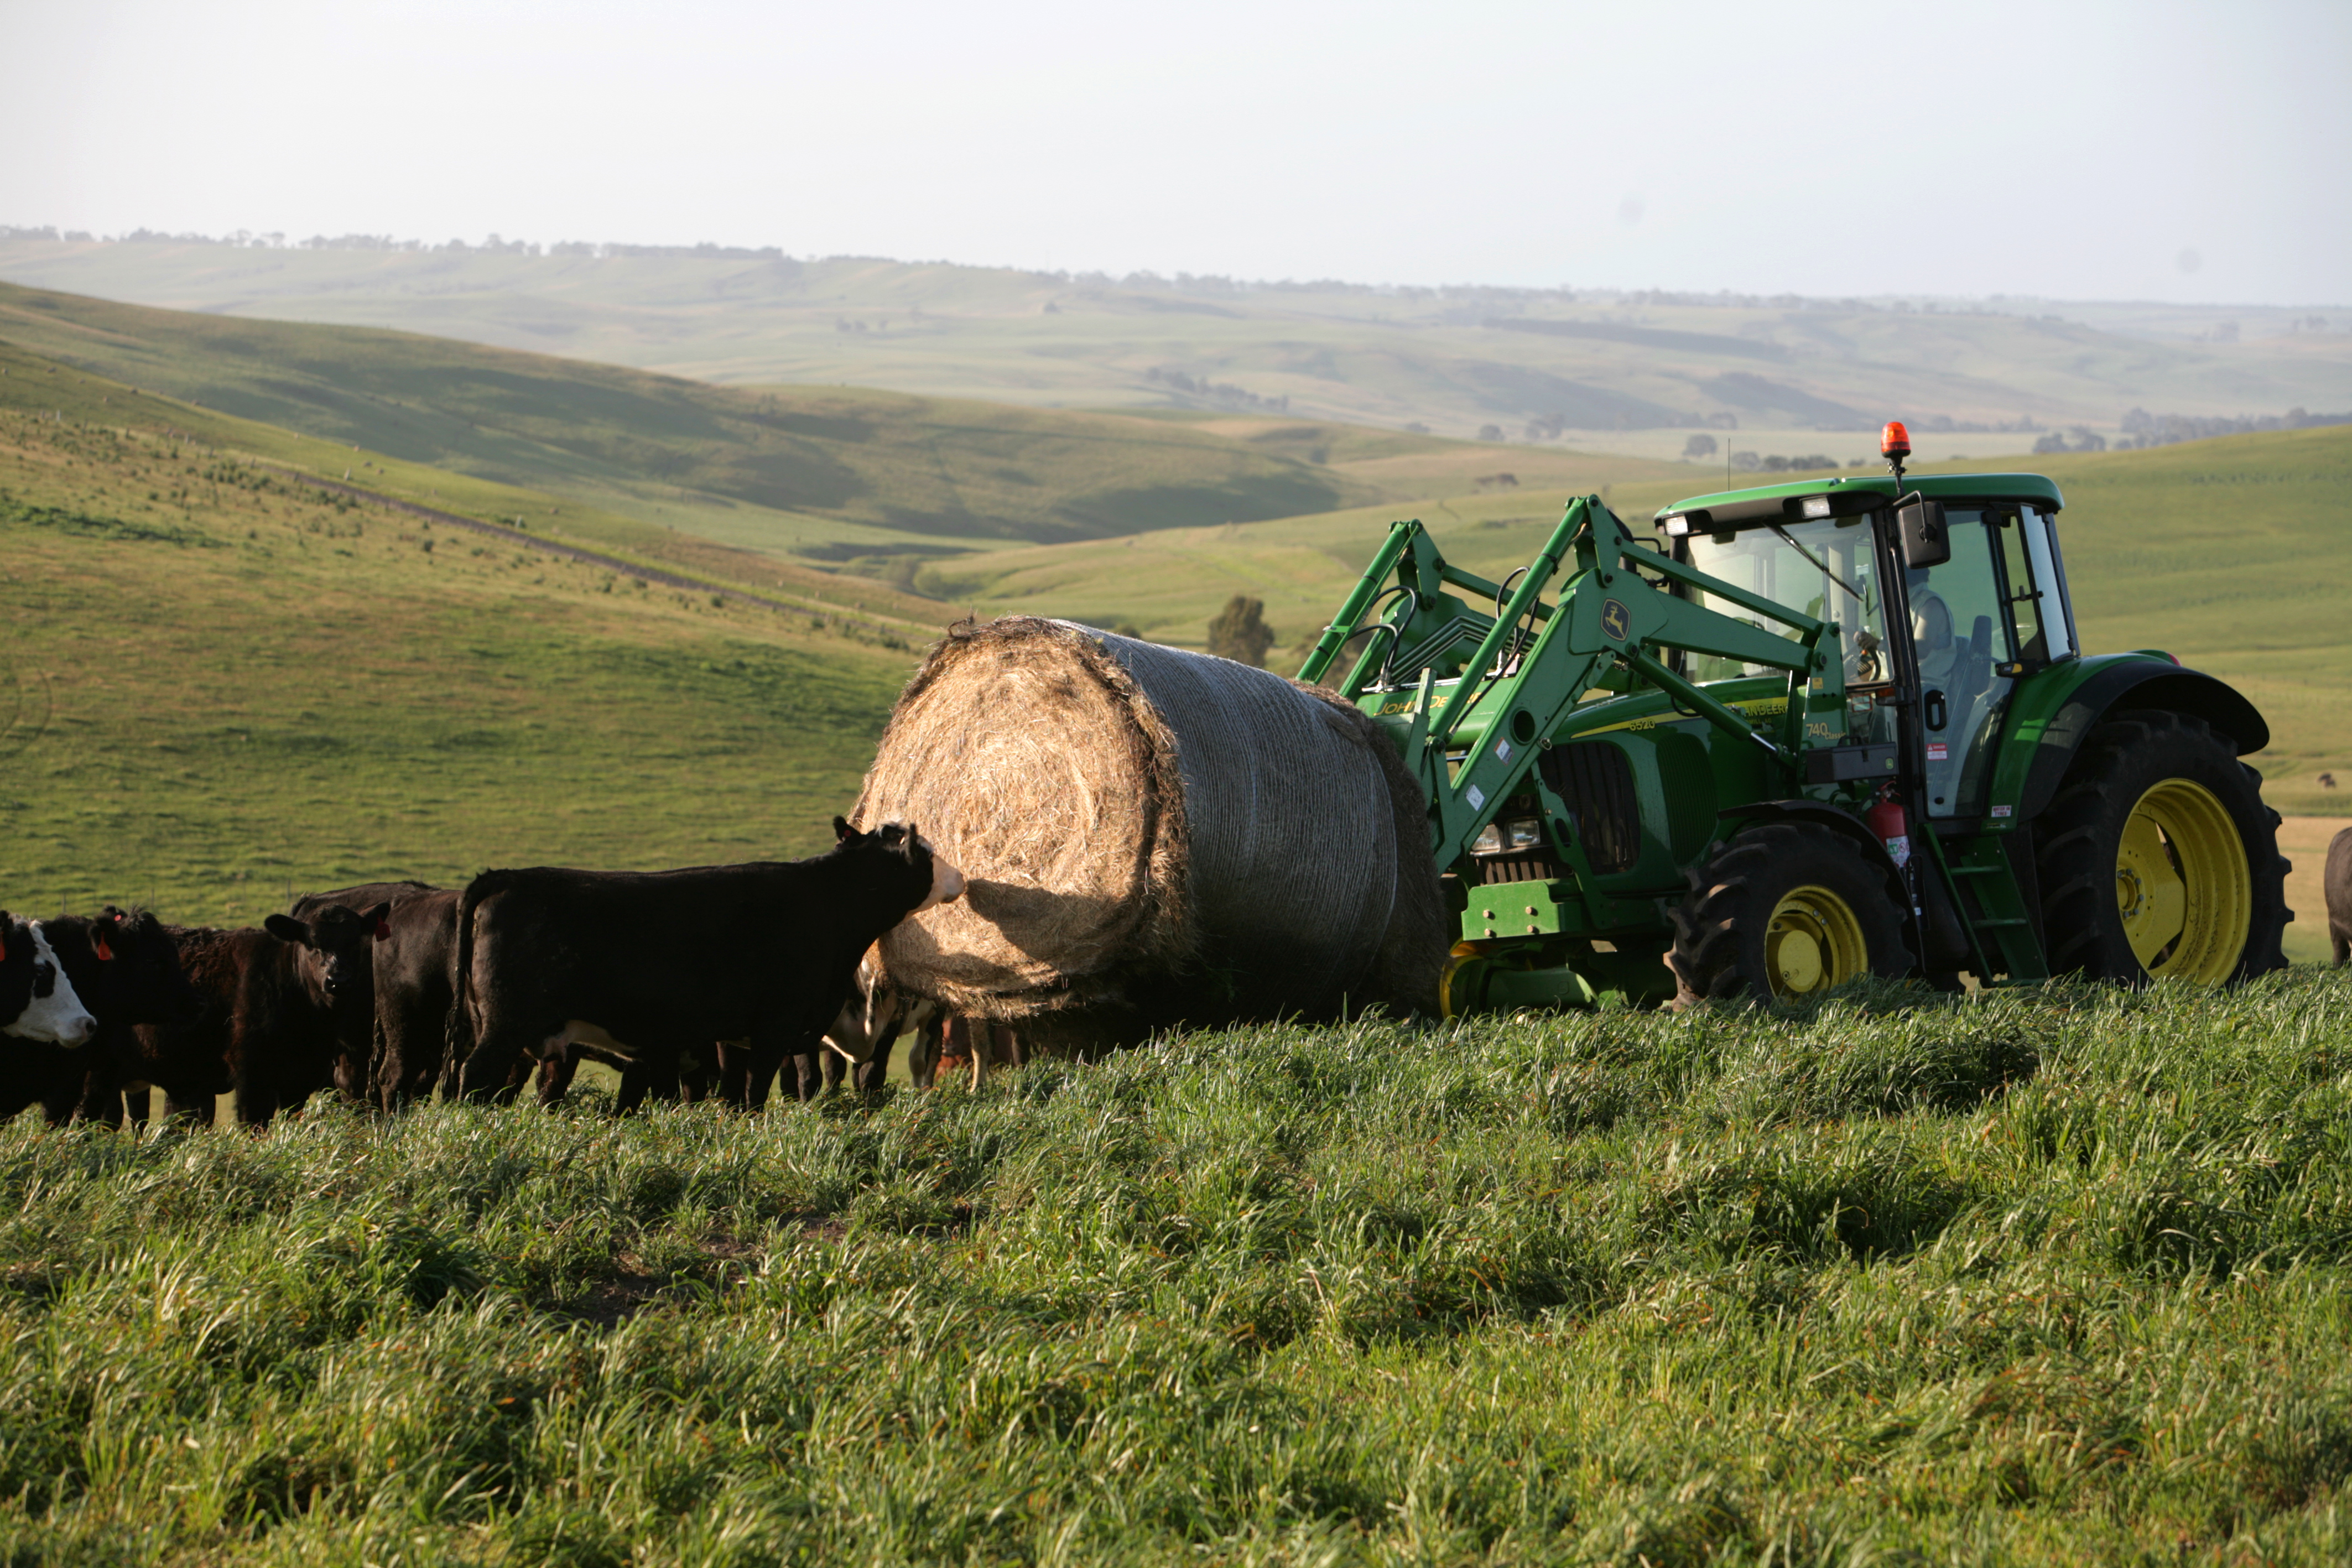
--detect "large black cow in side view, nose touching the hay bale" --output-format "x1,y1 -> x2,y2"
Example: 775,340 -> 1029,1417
449,818 -> 964,1109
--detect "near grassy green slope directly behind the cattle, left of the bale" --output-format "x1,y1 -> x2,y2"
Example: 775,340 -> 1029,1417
0,399 -> 913,924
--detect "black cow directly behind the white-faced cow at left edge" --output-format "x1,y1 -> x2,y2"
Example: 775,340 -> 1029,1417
0,905 -> 197,1126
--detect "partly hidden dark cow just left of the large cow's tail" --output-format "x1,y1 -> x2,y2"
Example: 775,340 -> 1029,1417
294,882 -> 459,1112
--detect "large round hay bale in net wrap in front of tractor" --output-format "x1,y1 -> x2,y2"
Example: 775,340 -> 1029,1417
856,616 -> 1446,1023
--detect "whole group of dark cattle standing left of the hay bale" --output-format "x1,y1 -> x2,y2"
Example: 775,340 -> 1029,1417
0,818 -> 983,1126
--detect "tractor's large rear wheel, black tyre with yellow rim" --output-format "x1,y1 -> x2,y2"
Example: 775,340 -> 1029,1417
2034,710 -> 2288,985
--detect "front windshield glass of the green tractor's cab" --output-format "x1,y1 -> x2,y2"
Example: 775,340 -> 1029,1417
1689,517 -> 1893,686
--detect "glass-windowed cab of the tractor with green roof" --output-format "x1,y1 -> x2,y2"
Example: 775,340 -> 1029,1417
1658,475 -> 2074,818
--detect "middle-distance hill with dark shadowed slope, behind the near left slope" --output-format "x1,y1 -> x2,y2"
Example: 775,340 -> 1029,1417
0,284 -> 1439,553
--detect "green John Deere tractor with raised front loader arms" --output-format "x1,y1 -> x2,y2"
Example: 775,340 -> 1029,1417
1298,425 -> 2293,1013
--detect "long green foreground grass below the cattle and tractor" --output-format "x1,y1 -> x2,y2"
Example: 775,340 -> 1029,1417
0,971 -> 2352,1568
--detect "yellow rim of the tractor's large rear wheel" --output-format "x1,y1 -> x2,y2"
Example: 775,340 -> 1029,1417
2115,778 -> 2253,985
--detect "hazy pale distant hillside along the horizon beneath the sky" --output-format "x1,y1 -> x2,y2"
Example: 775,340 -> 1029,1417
0,231 -> 2352,461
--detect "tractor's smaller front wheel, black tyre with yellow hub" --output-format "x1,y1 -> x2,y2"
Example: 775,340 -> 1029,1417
1665,823 -> 1912,1006
